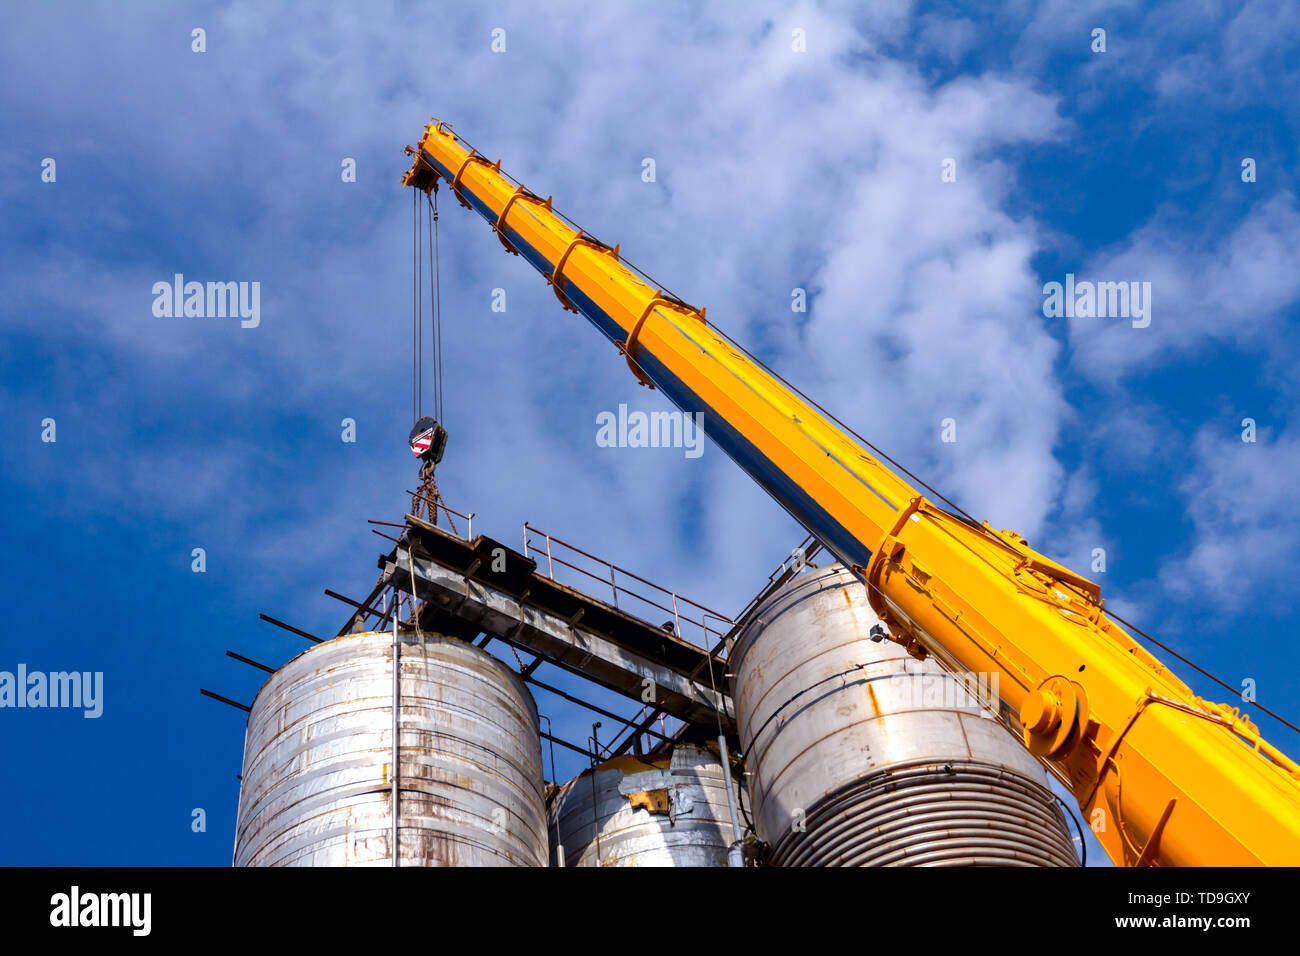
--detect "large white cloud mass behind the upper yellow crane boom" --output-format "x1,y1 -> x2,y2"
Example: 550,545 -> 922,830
0,4 -> 1062,621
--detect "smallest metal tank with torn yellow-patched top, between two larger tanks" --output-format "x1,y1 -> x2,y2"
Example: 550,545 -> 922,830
550,744 -> 735,866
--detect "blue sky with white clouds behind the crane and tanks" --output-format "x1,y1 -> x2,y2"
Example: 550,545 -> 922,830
0,0 -> 1300,865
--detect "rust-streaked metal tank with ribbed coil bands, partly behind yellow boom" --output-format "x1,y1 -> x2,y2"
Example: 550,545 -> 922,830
731,564 -> 1079,866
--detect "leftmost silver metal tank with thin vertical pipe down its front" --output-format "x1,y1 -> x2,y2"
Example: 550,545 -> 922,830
235,632 -> 547,866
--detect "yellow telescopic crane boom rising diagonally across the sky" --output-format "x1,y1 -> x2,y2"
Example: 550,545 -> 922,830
403,115 -> 1300,866
